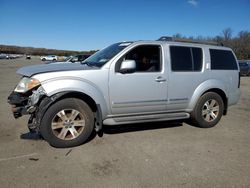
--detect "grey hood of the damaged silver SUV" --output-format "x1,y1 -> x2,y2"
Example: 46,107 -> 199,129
17,63 -> 96,77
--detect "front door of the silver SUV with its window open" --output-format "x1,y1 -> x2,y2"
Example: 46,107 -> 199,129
109,45 -> 167,115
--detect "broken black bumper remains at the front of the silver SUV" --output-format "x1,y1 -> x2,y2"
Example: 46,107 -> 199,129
8,92 -> 29,118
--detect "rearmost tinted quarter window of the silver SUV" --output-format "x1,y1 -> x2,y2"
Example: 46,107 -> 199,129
209,49 -> 238,70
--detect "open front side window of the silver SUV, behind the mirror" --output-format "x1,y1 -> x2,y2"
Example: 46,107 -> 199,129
115,45 -> 161,72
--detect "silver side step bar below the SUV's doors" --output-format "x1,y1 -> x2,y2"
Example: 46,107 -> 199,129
103,112 -> 190,125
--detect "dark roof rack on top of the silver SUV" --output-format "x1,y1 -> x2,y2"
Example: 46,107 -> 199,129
158,36 -> 224,46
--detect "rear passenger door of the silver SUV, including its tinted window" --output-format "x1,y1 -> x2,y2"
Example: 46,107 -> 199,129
167,45 -> 206,111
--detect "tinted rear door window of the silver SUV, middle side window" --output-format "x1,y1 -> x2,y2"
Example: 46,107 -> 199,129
170,46 -> 202,72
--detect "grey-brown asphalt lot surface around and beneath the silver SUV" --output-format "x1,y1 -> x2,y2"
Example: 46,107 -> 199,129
0,57 -> 250,188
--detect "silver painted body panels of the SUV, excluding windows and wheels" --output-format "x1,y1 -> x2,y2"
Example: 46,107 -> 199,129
15,41 -> 240,122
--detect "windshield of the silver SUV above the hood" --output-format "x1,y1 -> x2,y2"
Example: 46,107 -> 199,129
82,43 -> 131,67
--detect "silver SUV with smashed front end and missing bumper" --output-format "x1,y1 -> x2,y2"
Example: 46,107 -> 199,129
8,37 -> 240,147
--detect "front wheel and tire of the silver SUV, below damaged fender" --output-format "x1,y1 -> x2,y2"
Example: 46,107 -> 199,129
40,98 -> 94,148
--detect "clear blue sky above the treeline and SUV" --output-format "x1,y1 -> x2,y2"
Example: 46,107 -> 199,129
0,0 -> 250,50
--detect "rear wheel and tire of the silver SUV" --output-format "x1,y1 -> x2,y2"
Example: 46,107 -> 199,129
191,92 -> 224,128
